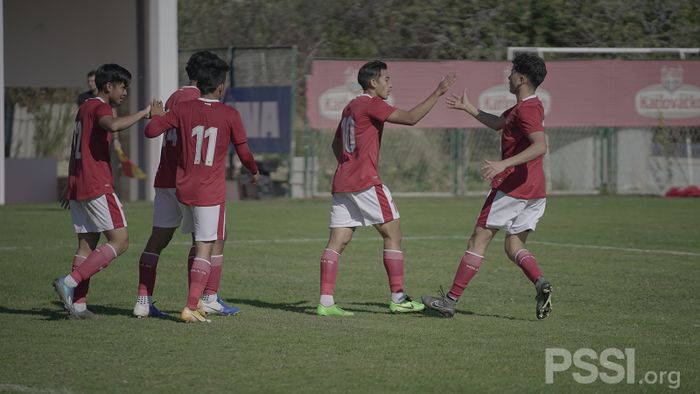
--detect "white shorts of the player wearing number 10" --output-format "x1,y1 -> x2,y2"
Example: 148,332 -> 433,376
329,185 -> 399,228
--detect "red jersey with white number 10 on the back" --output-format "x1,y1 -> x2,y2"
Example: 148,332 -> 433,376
332,94 -> 396,193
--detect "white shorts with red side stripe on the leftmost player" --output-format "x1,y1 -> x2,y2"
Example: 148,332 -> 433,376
69,193 -> 126,234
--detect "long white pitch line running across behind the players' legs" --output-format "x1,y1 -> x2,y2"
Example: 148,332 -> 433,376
0,235 -> 700,257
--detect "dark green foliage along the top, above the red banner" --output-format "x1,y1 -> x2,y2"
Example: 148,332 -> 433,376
179,0 -> 700,62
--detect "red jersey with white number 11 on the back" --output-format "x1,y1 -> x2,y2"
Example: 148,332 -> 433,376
146,98 -> 258,206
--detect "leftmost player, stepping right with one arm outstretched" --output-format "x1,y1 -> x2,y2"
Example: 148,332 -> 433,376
53,64 -> 151,319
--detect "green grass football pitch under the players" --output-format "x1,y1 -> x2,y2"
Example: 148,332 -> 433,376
0,196 -> 700,393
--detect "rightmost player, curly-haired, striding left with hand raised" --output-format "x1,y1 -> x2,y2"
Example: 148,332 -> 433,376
422,54 -> 552,319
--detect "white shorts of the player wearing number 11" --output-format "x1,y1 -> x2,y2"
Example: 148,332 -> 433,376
180,203 -> 226,241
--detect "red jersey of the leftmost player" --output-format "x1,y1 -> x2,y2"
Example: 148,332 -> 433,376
66,97 -> 114,200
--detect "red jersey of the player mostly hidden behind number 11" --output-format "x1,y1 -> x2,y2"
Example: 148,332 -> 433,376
153,86 -> 201,188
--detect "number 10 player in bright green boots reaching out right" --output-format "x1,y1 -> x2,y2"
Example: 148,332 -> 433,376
316,61 -> 455,316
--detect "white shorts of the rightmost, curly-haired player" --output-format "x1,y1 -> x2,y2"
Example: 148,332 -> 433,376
476,189 -> 547,234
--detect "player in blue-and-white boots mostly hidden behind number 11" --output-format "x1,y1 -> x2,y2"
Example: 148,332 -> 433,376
133,51 -> 240,318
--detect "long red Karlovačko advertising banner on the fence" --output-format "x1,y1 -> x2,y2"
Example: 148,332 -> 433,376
306,60 -> 700,128
